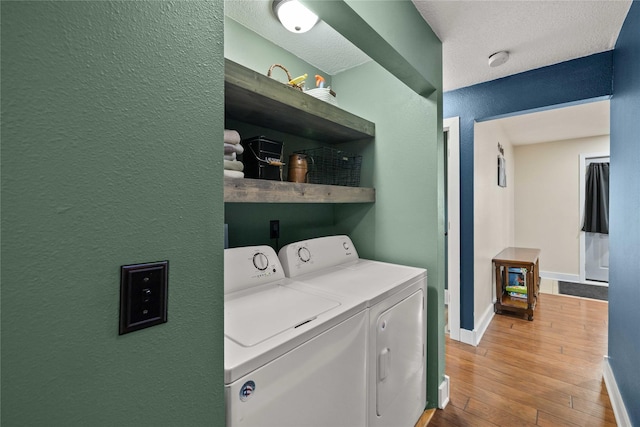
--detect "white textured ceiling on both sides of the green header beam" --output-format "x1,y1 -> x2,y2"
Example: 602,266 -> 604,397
225,0 -> 631,91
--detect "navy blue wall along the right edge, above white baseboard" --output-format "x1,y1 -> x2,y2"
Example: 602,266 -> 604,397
609,1 -> 640,426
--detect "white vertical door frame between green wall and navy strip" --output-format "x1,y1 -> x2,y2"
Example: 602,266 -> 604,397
442,117 -> 460,341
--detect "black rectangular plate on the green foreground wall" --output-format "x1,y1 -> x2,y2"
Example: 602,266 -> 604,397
120,261 -> 169,335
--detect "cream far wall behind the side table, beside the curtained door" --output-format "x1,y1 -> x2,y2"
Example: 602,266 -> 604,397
514,135 -> 609,276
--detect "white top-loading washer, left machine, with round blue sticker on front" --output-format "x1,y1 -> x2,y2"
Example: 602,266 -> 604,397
224,246 -> 368,427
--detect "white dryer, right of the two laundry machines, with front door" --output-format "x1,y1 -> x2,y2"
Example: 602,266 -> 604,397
278,236 -> 427,427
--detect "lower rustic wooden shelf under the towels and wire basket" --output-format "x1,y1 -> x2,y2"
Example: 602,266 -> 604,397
224,177 -> 376,203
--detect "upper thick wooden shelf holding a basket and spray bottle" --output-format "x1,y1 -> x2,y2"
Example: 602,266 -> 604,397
224,59 -> 375,143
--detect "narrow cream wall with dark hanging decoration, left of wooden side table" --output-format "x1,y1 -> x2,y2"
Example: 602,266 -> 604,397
473,122 -> 516,330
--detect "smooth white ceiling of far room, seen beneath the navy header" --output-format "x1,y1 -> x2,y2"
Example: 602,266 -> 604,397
493,100 -> 609,145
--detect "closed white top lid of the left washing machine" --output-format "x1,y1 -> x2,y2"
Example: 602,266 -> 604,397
224,284 -> 340,347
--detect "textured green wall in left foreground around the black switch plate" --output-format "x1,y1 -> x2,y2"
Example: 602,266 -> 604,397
1,0 -> 224,426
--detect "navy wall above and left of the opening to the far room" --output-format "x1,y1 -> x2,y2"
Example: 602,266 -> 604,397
443,51 -> 612,330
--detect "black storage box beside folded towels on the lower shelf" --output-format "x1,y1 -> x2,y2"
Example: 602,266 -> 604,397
242,136 -> 283,181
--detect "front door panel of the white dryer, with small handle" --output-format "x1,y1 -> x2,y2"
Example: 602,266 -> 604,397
375,290 -> 426,425
